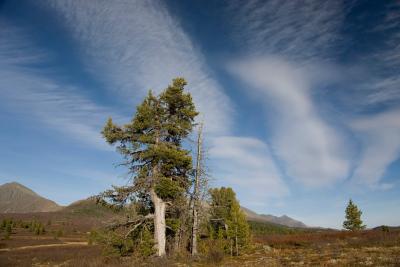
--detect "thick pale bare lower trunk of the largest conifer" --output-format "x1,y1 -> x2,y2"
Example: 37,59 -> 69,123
150,189 -> 166,256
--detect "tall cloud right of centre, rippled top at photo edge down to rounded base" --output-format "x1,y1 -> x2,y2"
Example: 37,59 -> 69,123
228,0 -> 350,187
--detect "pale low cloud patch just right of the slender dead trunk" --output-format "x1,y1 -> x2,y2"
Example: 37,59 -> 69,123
209,136 -> 289,206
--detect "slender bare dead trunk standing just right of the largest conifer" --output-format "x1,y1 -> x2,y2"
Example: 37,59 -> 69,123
192,123 -> 203,255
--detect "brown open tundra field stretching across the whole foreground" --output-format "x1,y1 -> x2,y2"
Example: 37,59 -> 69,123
0,214 -> 400,266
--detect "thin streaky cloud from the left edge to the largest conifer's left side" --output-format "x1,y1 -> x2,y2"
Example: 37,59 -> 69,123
0,71 -> 115,150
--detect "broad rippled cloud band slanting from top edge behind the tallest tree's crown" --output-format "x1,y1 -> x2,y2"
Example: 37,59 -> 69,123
40,1 -> 232,133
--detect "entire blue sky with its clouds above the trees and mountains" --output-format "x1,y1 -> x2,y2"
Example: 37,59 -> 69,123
0,0 -> 400,228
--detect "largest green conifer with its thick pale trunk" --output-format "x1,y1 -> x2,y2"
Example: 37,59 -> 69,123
102,78 -> 198,256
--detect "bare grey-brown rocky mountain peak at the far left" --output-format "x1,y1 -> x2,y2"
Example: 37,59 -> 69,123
0,182 -> 62,213
